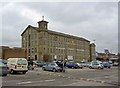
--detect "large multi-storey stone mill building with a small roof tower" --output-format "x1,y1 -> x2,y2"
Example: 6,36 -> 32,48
21,19 -> 95,61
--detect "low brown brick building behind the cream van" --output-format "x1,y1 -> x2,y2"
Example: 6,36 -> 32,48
0,46 -> 27,60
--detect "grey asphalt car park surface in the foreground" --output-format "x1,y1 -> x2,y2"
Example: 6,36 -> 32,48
1,67 -> 118,86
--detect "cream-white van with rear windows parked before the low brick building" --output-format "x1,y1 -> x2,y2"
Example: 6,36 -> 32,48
7,58 -> 28,74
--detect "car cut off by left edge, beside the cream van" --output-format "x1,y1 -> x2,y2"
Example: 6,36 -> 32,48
0,60 -> 9,76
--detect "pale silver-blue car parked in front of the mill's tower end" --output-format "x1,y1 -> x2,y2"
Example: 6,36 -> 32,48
42,63 -> 65,72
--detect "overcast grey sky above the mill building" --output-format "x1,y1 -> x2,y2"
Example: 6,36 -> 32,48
0,2 -> 118,53
